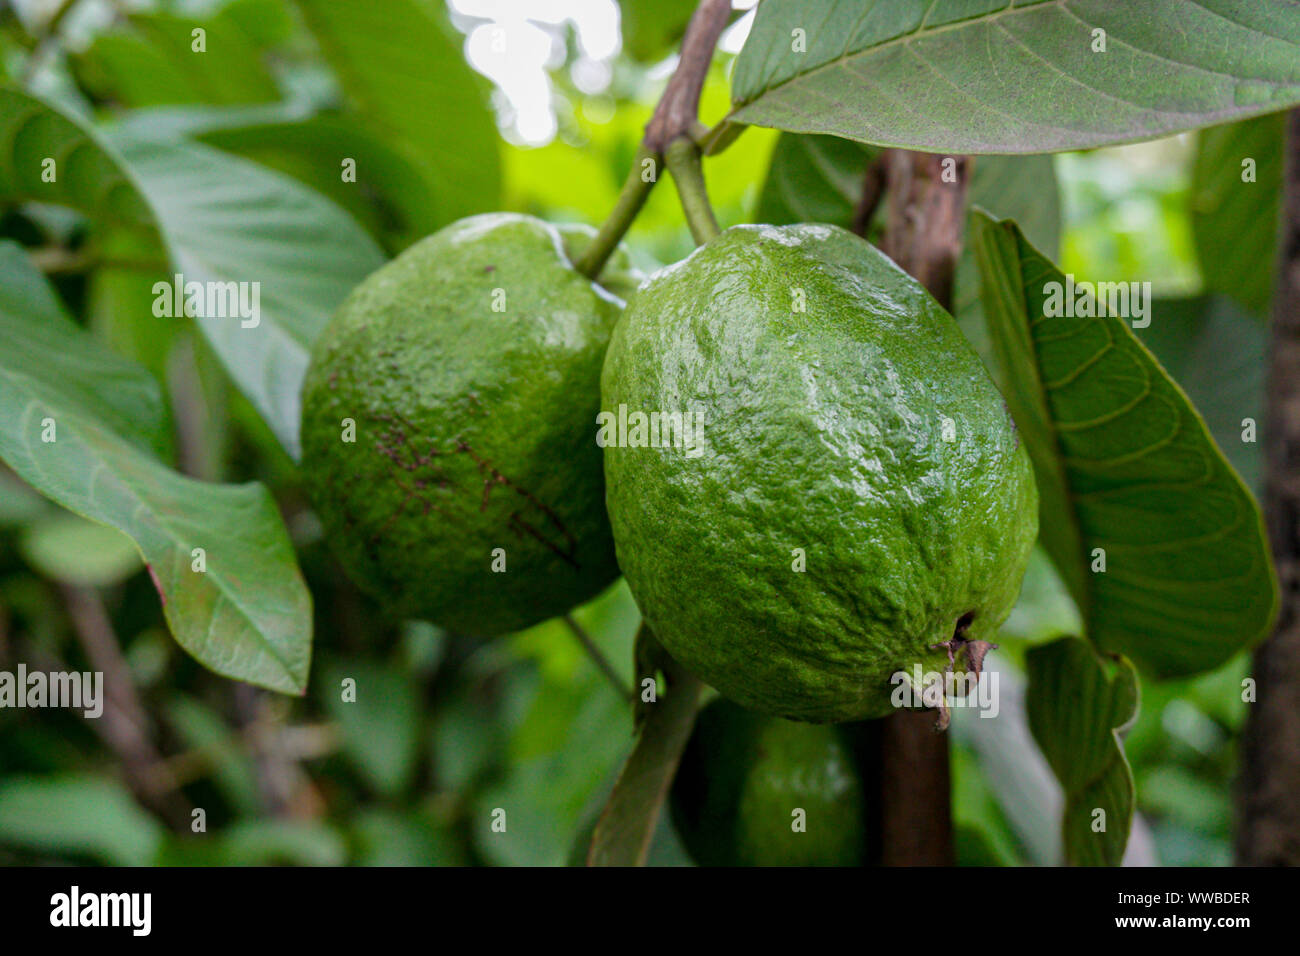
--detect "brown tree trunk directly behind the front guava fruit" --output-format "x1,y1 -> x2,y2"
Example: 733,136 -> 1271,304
879,150 -> 970,866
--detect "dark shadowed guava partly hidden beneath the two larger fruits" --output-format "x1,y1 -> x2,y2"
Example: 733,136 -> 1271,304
670,698 -> 867,866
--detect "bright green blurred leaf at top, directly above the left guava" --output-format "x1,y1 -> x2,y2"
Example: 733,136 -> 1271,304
298,0 -> 501,222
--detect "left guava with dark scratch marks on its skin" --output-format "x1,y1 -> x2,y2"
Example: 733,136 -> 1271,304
302,213 -> 623,637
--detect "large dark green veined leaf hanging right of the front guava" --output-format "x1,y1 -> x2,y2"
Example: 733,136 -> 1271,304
971,212 -> 1277,676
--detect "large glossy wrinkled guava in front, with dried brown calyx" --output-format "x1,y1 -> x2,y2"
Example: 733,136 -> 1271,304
602,224 -> 1037,722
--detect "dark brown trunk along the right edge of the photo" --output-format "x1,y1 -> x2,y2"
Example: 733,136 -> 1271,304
1236,109 -> 1300,866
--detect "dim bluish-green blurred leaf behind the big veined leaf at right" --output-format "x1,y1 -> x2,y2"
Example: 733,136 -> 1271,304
1136,295 -> 1269,494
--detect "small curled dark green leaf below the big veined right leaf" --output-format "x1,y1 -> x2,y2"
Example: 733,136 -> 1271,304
1024,637 -> 1139,866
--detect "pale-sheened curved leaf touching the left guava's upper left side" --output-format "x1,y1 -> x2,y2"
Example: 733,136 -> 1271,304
0,88 -> 384,457
